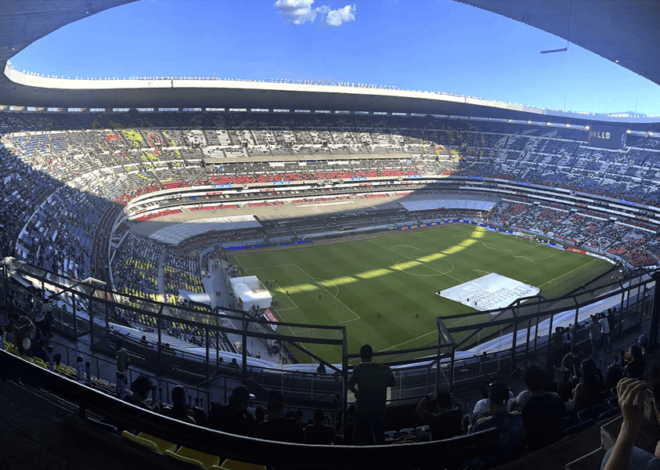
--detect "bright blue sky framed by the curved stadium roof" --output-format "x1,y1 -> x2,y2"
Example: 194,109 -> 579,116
12,0 -> 660,115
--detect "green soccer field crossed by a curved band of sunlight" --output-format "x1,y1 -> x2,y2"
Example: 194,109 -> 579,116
230,224 -> 611,363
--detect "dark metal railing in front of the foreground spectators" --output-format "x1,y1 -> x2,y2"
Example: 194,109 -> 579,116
3,262 -> 658,409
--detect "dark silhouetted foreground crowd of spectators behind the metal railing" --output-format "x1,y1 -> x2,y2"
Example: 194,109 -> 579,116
81,328 -> 657,469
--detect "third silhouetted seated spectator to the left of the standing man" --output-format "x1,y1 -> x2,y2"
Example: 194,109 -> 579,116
208,385 -> 254,436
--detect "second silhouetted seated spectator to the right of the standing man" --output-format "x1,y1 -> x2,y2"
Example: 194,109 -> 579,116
469,380 -> 523,467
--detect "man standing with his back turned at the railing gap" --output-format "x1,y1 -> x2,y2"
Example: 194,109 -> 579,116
348,344 -> 396,445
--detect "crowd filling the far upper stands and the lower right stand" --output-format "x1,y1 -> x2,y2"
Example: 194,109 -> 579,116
0,112 -> 660,304
